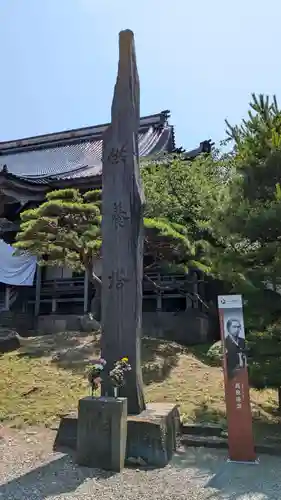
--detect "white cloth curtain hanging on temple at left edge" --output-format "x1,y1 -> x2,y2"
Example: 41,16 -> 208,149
0,240 -> 36,286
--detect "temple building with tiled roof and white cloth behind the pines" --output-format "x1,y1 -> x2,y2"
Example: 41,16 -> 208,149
0,111 -> 212,315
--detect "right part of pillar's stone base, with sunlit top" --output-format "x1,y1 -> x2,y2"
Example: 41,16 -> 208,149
126,403 -> 180,467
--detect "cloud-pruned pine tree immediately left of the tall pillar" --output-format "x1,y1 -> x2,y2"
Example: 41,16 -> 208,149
14,189 -> 101,318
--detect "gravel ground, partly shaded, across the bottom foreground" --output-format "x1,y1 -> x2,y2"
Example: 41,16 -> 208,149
0,428 -> 281,500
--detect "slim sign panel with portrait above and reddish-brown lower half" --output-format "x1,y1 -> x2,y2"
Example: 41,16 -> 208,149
218,295 -> 256,462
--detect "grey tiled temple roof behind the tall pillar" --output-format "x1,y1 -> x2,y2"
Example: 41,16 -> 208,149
0,112 -> 173,184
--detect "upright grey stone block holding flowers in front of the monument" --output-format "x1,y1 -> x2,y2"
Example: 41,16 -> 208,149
76,397 -> 127,472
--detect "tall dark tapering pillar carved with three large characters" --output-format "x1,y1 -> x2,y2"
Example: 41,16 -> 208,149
101,30 -> 145,414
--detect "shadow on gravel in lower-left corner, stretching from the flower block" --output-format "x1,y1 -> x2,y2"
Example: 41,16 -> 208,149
0,455 -> 115,500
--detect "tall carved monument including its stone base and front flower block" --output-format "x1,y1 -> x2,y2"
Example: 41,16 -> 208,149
73,30 -> 179,471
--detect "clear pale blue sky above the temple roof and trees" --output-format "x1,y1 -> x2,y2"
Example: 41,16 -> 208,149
0,0 -> 281,149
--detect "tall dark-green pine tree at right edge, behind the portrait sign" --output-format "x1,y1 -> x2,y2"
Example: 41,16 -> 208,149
219,95 -> 281,408
